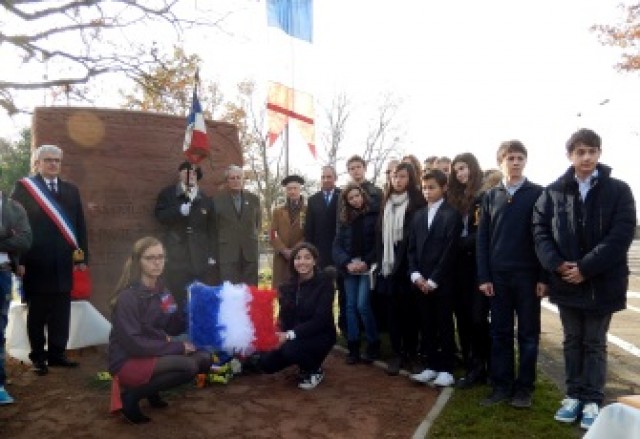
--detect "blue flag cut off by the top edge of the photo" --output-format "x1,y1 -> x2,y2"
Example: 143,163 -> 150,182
267,0 -> 313,43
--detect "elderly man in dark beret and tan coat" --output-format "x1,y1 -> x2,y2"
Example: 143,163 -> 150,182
270,175 -> 307,288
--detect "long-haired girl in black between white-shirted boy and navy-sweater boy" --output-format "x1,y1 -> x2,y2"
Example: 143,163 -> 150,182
447,152 -> 490,388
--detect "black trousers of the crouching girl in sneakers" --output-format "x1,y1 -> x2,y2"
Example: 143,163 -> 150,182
260,334 -> 336,373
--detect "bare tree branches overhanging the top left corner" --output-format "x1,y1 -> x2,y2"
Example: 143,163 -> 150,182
0,0 -> 229,115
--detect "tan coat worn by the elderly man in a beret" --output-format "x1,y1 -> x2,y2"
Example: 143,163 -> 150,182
270,199 -> 307,287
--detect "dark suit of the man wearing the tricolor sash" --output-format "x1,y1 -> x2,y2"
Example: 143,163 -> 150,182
11,175 -> 89,362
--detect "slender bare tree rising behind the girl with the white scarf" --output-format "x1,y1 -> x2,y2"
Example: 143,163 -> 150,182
362,93 -> 401,186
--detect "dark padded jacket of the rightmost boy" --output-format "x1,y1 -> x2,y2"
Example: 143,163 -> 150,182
533,164 -> 637,313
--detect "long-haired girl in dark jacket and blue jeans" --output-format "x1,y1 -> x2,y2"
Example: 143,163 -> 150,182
333,183 -> 380,364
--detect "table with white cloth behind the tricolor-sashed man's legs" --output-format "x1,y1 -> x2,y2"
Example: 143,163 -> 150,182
5,300 -> 111,363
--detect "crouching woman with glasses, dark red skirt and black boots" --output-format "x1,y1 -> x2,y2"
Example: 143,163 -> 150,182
109,237 -> 210,424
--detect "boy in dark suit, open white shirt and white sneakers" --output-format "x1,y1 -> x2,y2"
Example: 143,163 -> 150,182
408,169 -> 462,387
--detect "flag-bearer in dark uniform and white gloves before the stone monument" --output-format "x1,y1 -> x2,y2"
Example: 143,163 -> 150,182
155,161 -> 215,306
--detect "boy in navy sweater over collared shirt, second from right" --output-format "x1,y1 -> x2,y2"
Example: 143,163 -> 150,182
476,140 -> 547,408
